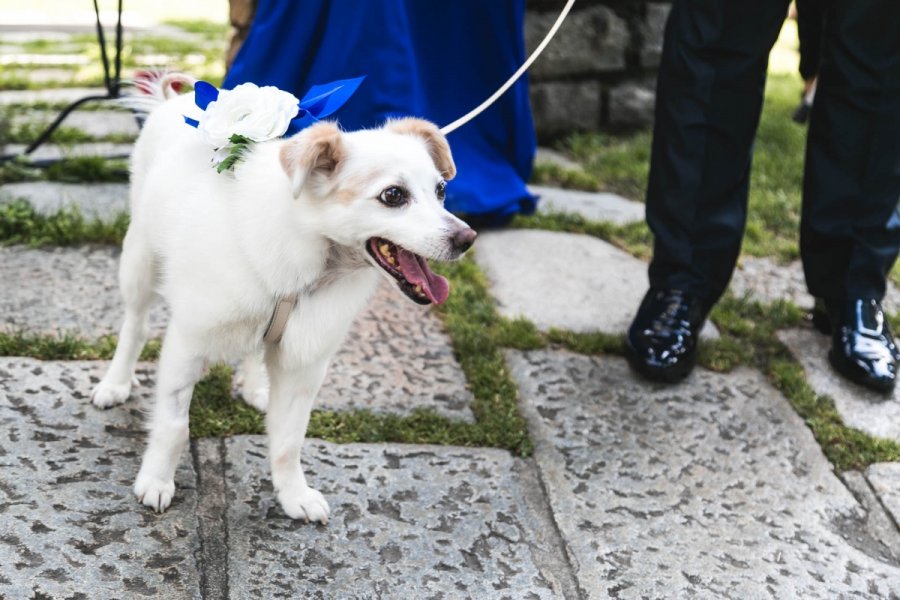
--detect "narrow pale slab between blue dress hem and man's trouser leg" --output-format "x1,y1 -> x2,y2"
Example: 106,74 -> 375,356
528,185 -> 645,225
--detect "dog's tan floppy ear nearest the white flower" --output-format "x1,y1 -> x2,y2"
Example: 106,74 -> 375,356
278,122 -> 345,198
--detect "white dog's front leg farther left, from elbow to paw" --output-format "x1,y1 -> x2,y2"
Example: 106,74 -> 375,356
134,321 -> 205,512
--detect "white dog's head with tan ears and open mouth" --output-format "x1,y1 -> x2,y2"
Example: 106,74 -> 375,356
280,119 -> 476,304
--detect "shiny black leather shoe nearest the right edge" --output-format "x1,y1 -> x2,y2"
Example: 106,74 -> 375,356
828,299 -> 900,392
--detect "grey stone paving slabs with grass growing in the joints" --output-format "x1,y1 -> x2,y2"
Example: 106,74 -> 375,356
0,24 -> 900,600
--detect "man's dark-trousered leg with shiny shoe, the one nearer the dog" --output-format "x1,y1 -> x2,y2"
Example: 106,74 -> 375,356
627,0 -> 788,381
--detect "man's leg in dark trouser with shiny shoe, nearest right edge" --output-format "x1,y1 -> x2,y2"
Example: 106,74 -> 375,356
800,0 -> 900,389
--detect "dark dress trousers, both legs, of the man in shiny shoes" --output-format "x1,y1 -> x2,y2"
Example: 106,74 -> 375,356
647,0 -> 900,308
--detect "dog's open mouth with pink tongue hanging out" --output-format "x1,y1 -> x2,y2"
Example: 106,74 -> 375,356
366,238 -> 450,304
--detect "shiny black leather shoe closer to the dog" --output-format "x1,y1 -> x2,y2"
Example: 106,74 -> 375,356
625,289 -> 706,383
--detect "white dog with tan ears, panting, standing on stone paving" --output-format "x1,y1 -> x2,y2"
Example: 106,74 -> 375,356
92,75 -> 476,523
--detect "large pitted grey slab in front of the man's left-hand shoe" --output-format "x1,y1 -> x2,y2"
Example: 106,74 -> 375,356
507,351 -> 900,600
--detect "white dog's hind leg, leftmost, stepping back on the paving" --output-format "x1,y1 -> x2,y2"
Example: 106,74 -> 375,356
91,229 -> 156,408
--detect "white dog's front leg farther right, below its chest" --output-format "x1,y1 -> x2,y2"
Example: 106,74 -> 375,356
266,360 -> 329,523
